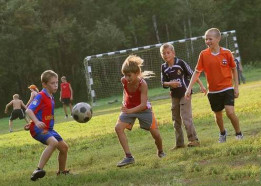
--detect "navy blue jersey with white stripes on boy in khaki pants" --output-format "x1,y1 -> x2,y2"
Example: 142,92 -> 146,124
161,57 -> 193,98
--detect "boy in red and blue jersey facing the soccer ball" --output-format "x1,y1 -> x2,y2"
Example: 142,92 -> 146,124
26,70 -> 69,181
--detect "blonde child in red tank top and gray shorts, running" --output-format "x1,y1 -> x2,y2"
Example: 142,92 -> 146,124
115,55 -> 165,167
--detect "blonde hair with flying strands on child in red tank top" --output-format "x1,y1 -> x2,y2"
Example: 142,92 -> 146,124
121,55 -> 154,79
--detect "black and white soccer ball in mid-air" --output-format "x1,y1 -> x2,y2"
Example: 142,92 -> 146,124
72,102 -> 92,123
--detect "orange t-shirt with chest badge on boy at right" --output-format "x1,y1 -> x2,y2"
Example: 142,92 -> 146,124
196,47 -> 236,92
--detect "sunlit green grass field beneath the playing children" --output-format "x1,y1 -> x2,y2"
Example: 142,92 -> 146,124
0,67 -> 261,186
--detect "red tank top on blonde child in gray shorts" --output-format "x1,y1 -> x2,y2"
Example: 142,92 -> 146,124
123,79 -> 151,110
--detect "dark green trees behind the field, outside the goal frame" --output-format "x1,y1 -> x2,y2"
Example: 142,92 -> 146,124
0,0 -> 261,116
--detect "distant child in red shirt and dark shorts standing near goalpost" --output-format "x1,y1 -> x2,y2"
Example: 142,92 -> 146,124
60,76 -> 73,119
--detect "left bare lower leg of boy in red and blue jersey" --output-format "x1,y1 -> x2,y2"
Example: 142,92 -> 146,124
38,136 -> 58,169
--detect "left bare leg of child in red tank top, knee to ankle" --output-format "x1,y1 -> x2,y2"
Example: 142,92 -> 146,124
115,121 -> 131,154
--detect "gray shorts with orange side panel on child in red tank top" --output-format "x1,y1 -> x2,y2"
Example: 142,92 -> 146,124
119,109 -> 158,130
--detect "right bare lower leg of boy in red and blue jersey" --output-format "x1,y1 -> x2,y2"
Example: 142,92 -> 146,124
57,141 -> 69,171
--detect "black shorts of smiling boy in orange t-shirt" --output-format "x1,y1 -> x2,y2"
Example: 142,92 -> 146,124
208,89 -> 235,112
